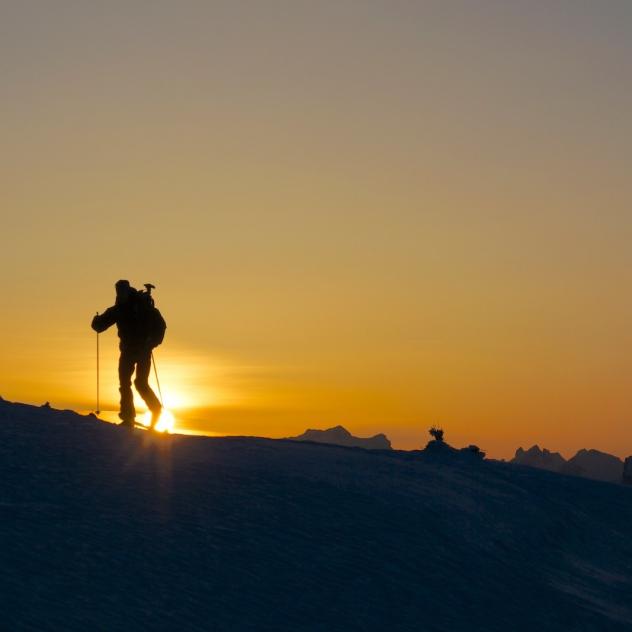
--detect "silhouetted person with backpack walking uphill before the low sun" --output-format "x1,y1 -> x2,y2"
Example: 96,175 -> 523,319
92,280 -> 167,428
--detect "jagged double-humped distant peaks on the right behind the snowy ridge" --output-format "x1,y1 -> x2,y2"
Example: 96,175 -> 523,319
511,445 -> 623,483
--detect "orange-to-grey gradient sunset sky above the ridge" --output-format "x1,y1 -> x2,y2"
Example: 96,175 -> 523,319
0,0 -> 632,457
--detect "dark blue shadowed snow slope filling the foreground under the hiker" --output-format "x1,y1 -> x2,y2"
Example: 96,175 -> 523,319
0,402 -> 632,632
